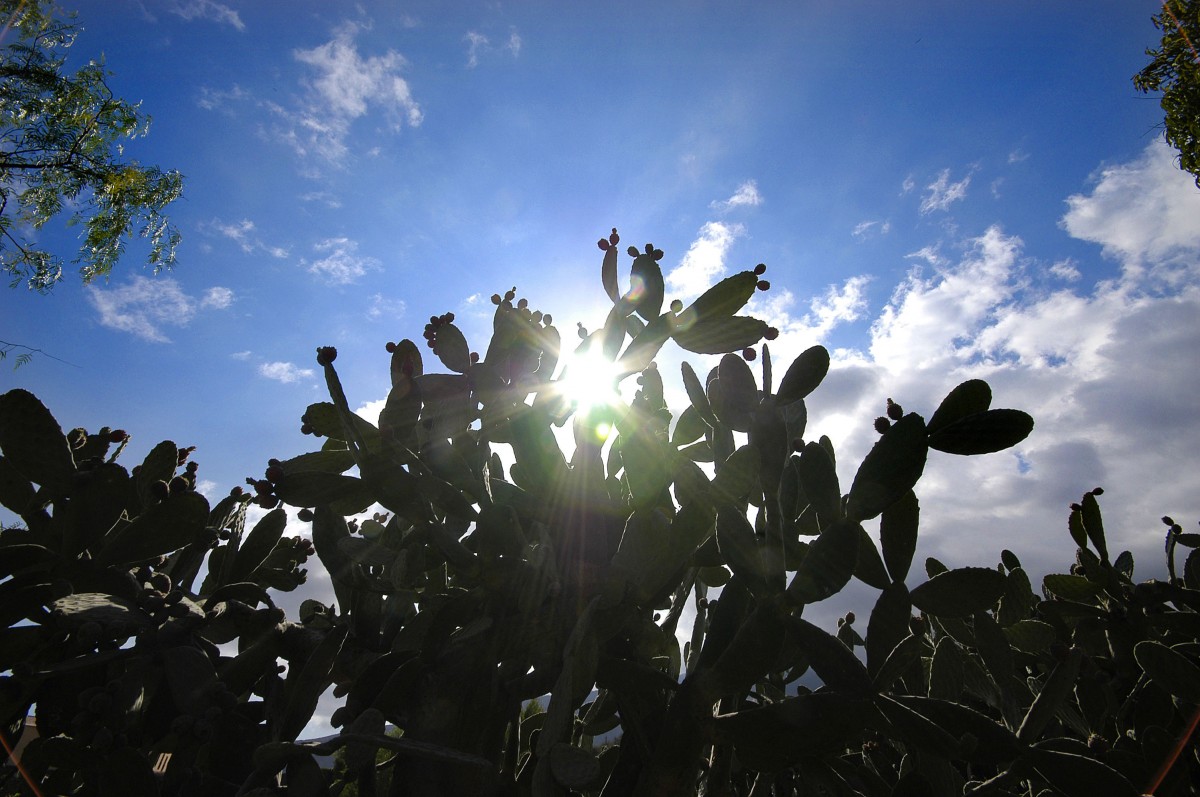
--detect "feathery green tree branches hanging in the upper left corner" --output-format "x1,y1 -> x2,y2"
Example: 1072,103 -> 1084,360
0,0 -> 182,292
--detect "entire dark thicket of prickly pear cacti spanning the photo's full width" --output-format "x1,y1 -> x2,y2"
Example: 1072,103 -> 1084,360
0,230 -> 1200,797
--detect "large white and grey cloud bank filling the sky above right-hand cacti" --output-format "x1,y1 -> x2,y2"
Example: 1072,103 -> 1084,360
756,147 -> 1200,583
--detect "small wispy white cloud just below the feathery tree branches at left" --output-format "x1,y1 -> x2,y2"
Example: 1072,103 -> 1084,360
88,276 -> 233,343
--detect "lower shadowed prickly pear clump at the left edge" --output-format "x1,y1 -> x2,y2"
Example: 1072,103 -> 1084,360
0,390 -> 338,795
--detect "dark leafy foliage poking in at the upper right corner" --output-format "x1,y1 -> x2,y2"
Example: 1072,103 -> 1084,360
1133,0 -> 1200,186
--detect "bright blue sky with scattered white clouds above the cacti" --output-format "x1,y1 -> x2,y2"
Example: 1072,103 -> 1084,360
0,0 -> 1200,734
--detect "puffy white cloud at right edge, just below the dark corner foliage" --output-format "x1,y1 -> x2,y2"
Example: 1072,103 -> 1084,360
1061,139 -> 1200,268
